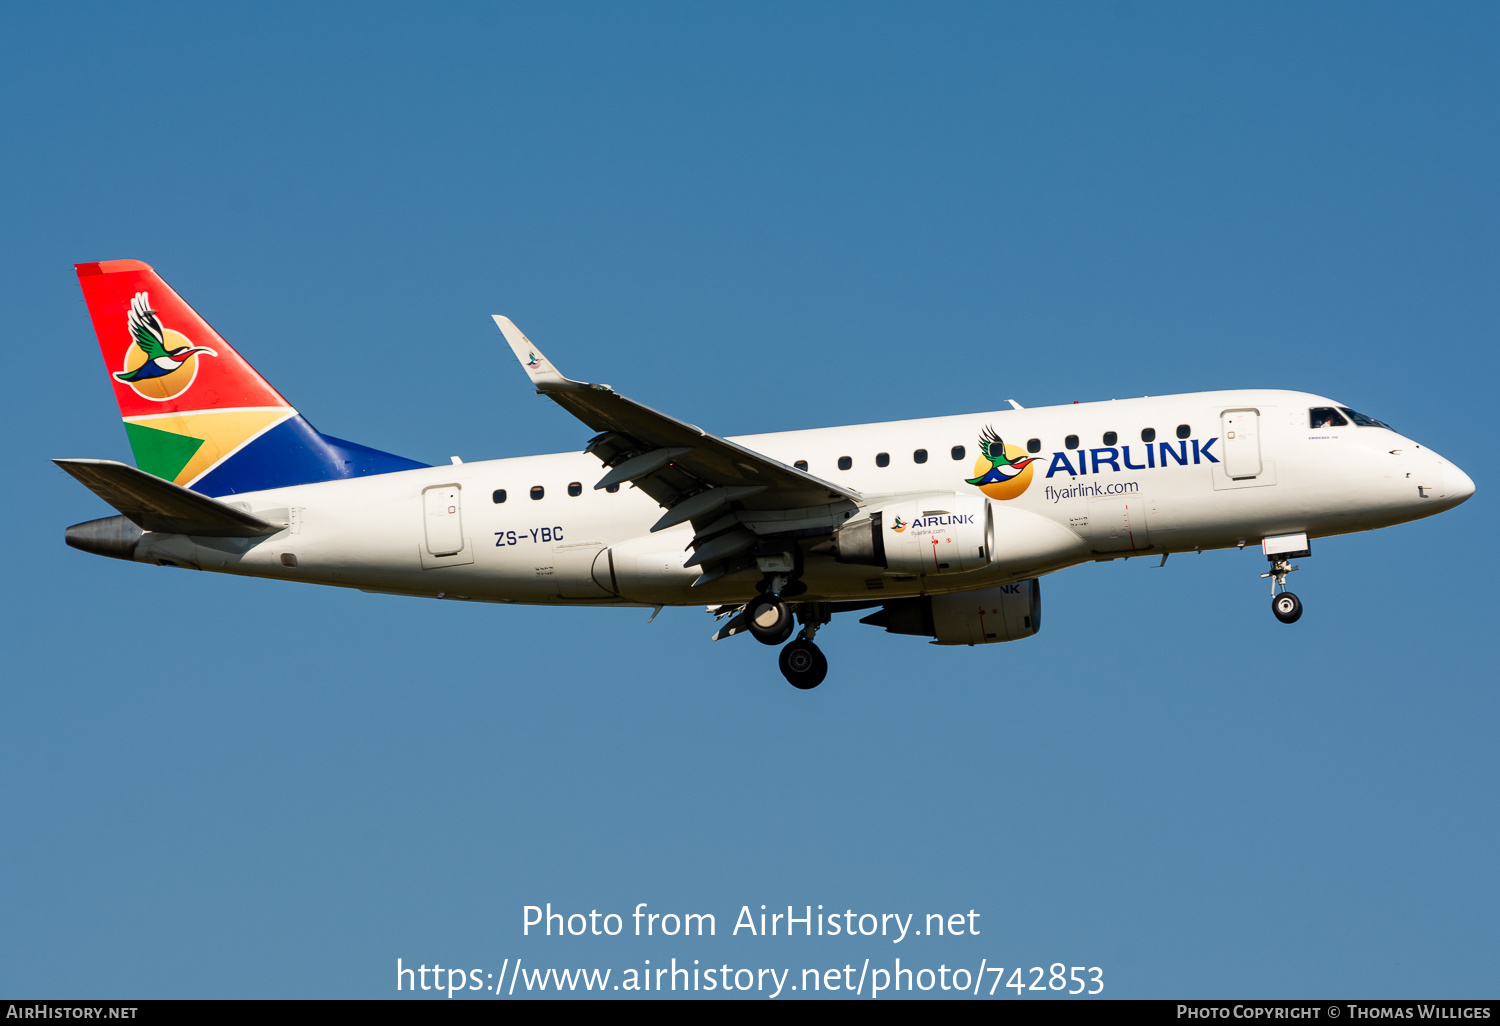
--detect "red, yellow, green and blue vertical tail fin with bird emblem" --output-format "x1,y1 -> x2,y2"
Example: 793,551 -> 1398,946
77,260 -> 426,495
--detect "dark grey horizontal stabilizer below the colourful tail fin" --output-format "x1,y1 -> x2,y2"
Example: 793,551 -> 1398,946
53,459 -> 284,539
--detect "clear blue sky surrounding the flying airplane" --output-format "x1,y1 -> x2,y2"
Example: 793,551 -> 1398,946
0,3 -> 1500,998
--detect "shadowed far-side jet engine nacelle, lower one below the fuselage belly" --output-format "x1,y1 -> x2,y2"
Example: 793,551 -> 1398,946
860,578 -> 1041,645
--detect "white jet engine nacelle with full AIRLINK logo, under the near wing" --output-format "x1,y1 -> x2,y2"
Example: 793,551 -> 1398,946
834,492 -> 995,575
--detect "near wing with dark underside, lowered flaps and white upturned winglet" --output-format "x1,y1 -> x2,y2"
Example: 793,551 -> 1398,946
495,314 -> 861,584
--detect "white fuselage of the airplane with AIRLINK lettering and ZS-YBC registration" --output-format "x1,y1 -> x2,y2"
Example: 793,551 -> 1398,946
137,390 -> 1473,605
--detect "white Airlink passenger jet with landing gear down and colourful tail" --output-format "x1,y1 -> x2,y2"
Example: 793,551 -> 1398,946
54,260 -> 1475,690
